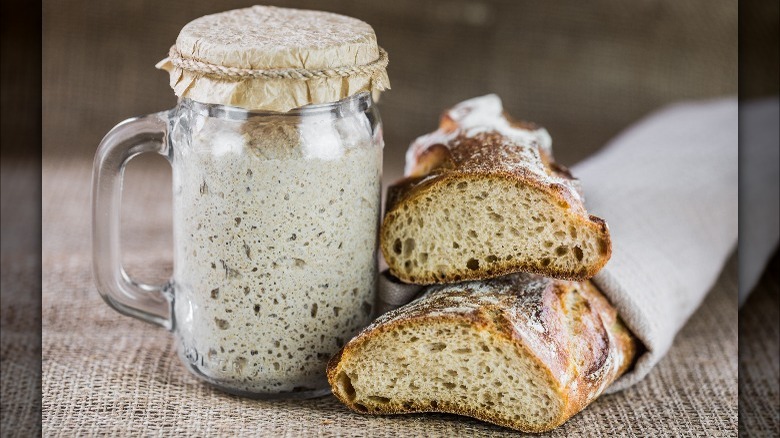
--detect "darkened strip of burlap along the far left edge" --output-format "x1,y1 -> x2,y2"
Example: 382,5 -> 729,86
0,162 -> 41,437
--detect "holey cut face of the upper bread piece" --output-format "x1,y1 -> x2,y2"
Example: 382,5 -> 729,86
381,174 -> 611,284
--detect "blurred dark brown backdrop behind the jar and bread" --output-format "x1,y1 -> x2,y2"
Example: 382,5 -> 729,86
43,0 -> 748,179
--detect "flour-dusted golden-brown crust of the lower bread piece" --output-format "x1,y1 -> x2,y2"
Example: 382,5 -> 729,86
327,274 -> 636,432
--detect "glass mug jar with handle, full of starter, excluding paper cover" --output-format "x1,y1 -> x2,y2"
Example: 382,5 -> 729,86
93,93 -> 383,398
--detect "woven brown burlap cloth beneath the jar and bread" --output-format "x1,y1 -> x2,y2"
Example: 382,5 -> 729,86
36,159 -> 737,437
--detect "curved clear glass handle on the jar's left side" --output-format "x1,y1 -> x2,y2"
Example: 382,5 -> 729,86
92,111 -> 174,330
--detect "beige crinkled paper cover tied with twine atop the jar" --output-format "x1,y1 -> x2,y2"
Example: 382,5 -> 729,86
157,6 -> 390,112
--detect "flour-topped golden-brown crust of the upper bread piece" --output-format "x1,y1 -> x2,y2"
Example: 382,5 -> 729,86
380,98 -> 612,284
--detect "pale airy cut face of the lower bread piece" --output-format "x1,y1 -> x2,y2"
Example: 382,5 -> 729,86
333,319 -> 564,431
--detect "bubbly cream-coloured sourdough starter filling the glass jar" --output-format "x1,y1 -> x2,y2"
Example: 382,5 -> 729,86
174,114 -> 381,393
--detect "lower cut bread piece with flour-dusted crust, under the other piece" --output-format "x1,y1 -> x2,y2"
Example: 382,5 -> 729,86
328,274 -> 636,432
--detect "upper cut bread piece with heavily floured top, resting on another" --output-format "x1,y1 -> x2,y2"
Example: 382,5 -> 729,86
380,95 -> 612,284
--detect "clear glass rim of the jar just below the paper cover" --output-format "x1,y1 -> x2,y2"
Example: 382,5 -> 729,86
178,91 -> 374,120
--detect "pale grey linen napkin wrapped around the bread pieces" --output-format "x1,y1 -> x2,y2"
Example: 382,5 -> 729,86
378,99 -> 738,392
